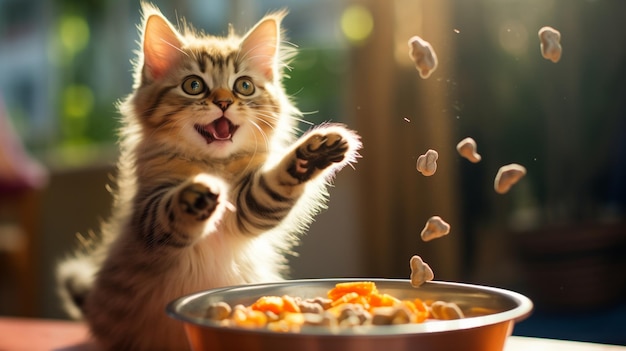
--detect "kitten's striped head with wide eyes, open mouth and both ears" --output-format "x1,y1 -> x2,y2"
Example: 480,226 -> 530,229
133,9 -> 283,158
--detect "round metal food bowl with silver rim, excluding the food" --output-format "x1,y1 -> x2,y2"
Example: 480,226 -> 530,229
167,278 -> 533,351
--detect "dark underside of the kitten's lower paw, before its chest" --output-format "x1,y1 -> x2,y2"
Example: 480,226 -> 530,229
178,183 -> 219,221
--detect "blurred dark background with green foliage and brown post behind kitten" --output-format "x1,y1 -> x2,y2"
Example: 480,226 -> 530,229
0,0 -> 626,345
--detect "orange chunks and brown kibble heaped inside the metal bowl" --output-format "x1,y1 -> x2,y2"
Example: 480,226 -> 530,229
206,282 -> 464,332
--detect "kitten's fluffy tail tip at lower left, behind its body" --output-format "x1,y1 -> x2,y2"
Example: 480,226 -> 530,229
56,253 -> 97,319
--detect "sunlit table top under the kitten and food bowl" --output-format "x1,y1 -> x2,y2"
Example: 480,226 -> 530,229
0,317 -> 626,351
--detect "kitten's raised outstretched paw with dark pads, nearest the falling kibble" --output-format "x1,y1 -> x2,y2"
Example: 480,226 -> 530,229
288,130 -> 356,182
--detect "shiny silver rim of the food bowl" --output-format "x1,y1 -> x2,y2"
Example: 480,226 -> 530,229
166,278 -> 533,336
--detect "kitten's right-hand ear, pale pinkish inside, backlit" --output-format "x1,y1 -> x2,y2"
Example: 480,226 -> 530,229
241,12 -> 286,80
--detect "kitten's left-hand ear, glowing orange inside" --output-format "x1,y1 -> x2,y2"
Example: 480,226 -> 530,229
142,11 -> 183,79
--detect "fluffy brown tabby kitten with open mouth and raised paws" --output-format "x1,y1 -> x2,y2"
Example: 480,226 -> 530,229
58,4 -> 361,350
